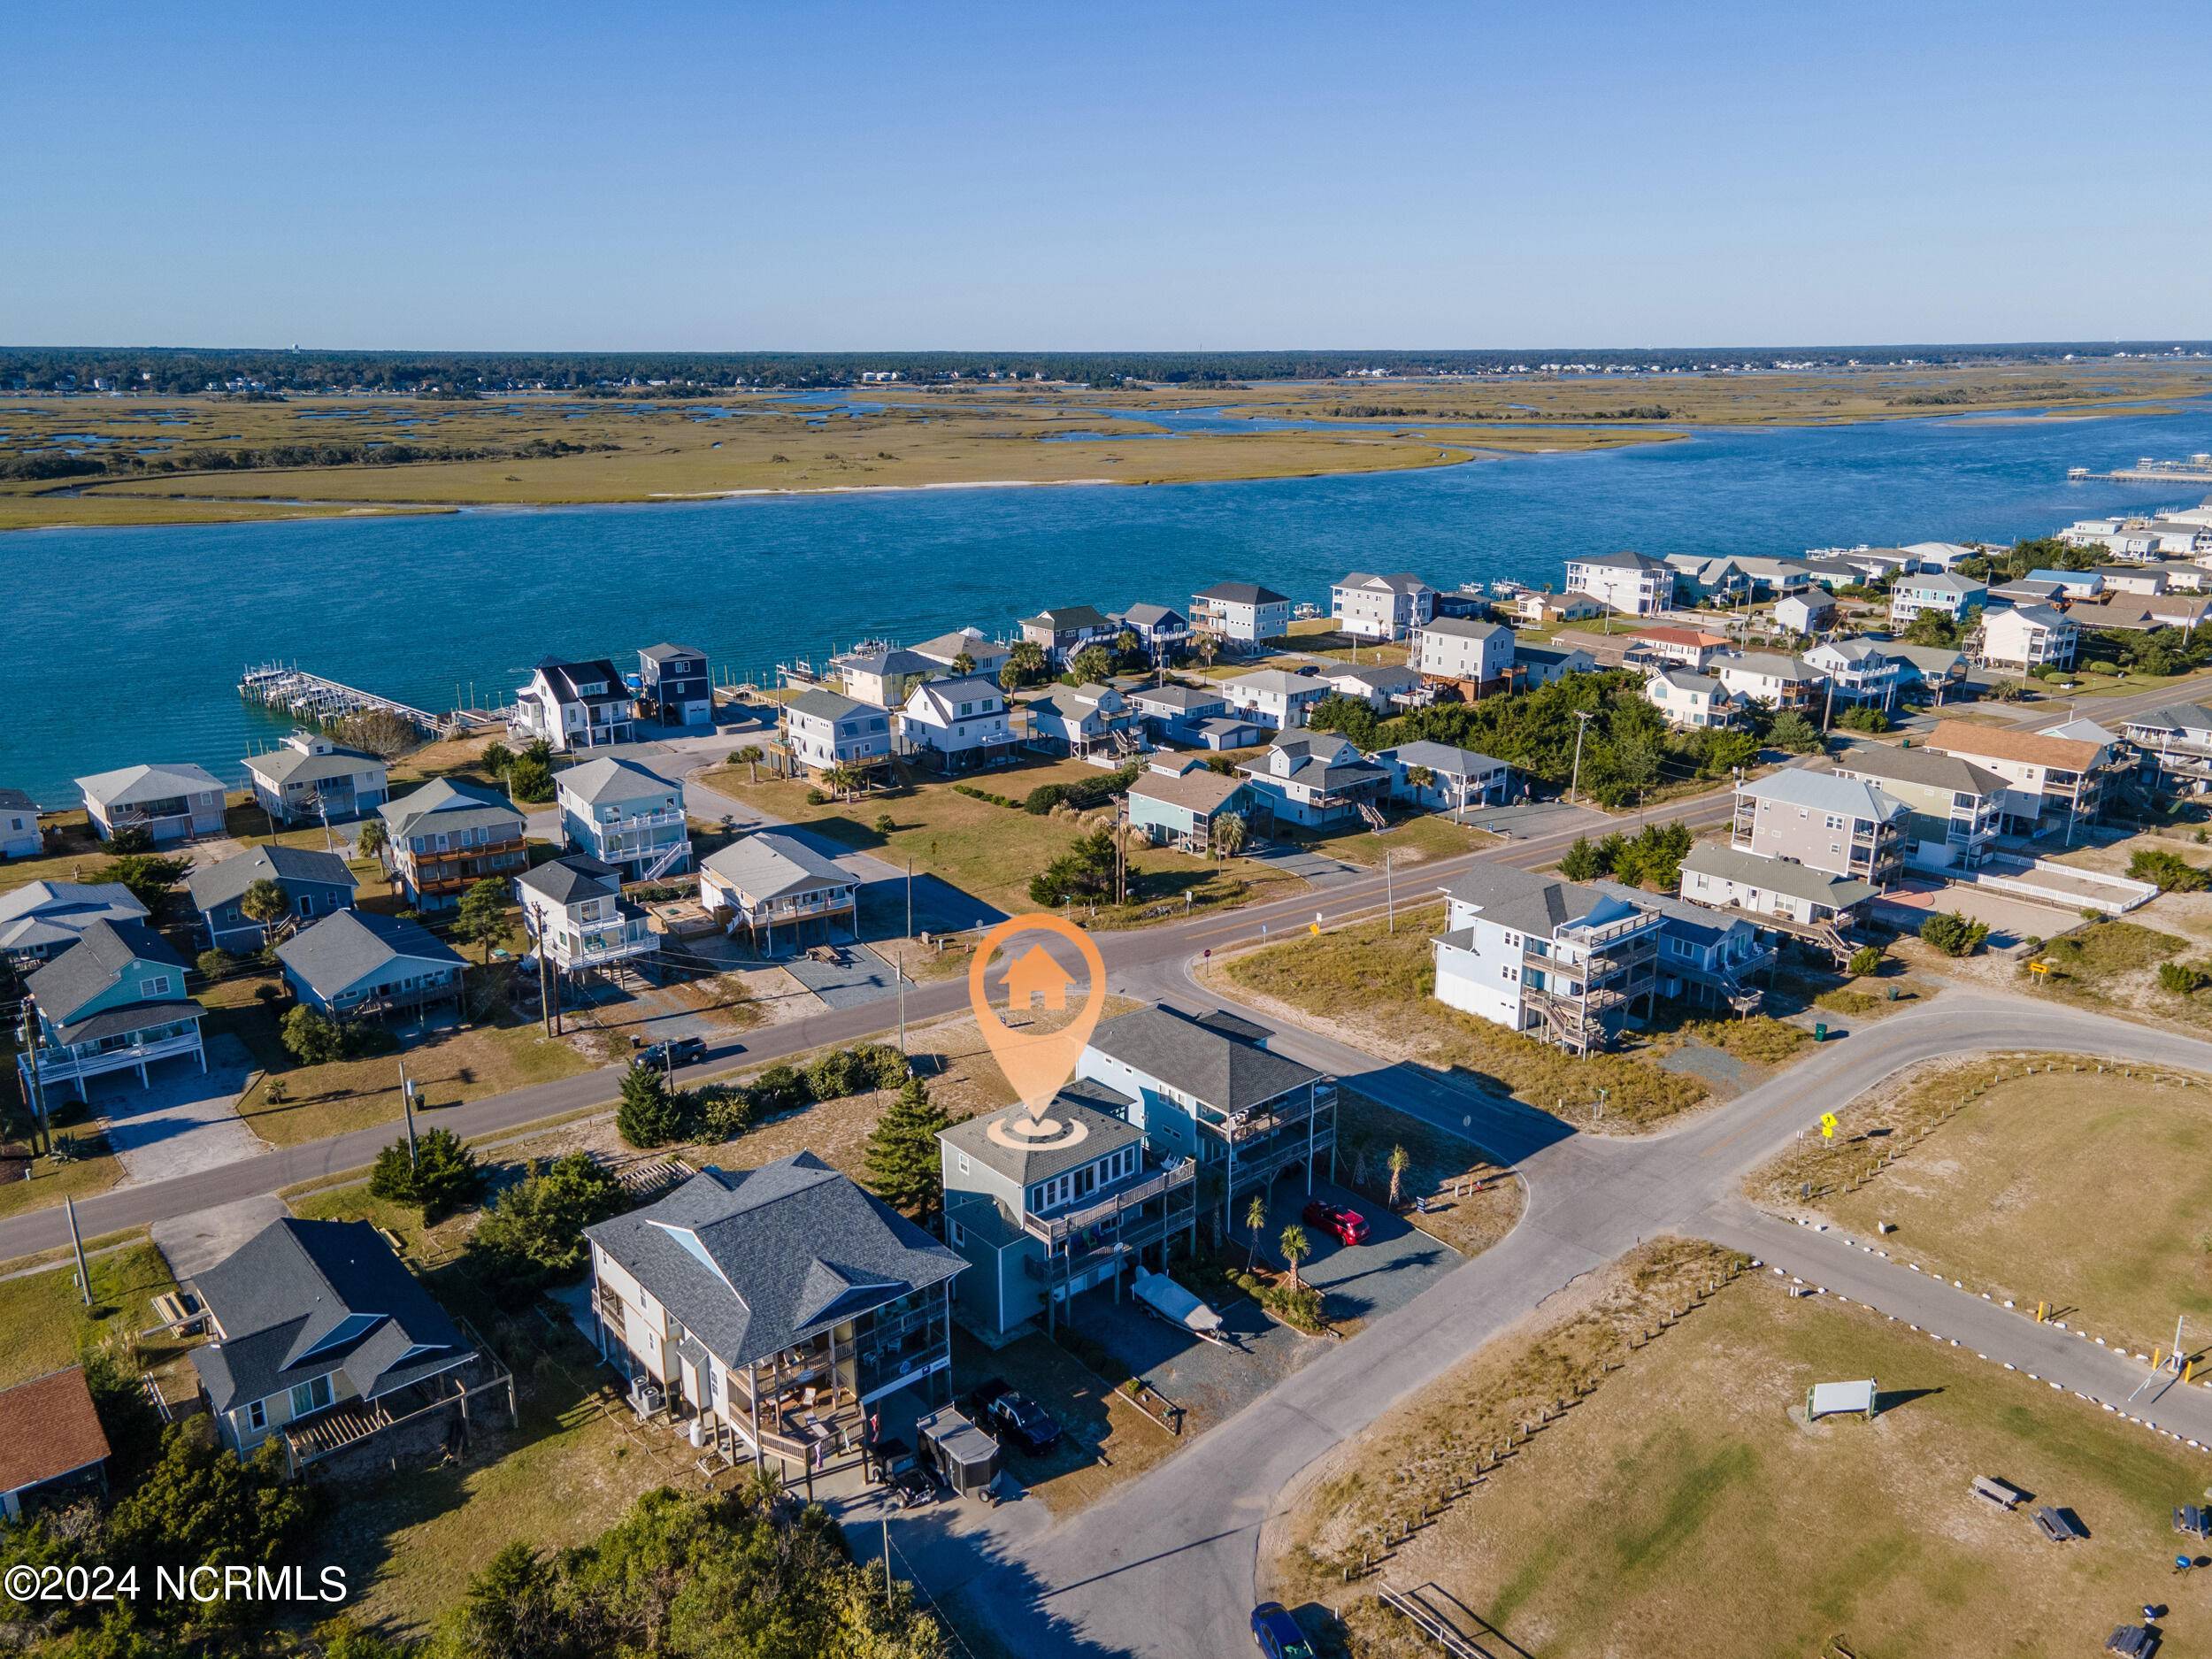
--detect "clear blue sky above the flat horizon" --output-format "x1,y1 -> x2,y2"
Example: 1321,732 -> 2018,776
0,0 -> 2212,349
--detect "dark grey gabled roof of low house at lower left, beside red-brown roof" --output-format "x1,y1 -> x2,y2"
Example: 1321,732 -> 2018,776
193,1217 -> 473,1411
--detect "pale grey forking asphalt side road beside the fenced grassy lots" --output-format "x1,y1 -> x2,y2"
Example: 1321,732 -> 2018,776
894,991 -> 2212,1657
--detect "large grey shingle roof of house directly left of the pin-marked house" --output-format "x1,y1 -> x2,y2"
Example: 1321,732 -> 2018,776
587,1153 -> 967,1365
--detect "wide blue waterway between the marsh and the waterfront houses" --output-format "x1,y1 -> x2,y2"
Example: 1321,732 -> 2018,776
0,401 -> 2212,805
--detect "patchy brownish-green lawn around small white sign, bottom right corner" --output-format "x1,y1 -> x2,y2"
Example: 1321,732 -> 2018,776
1263,1274 -> 2212,1659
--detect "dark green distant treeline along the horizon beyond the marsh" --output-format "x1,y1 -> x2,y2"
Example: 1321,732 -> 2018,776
12,341 -> 2203,398
